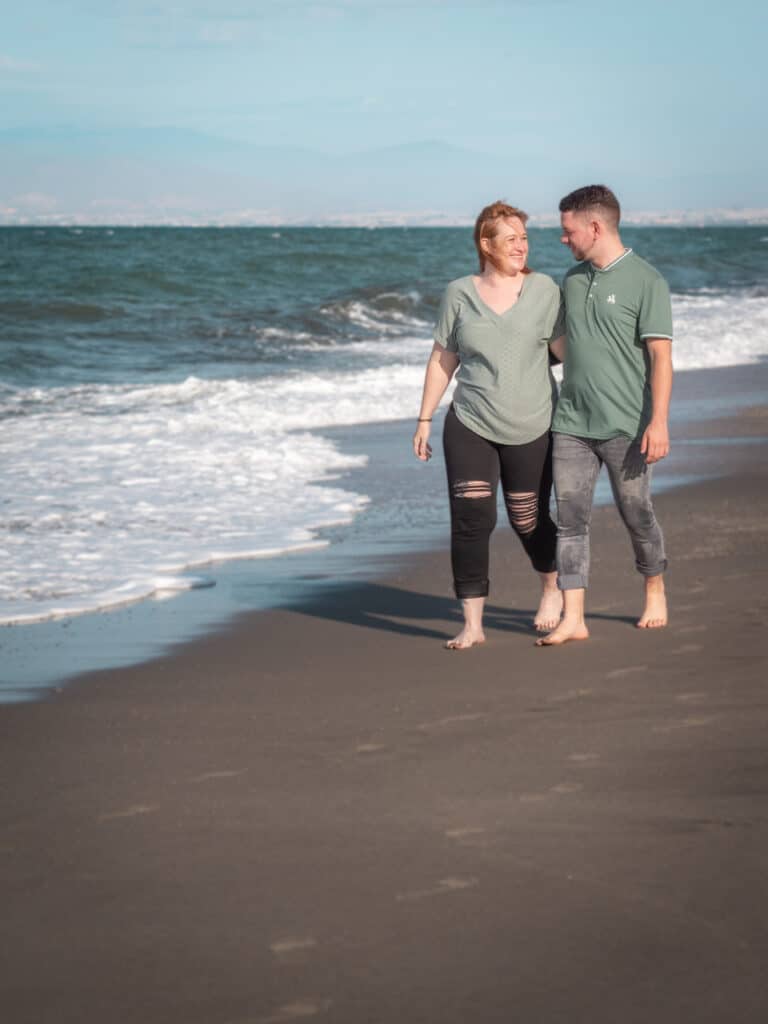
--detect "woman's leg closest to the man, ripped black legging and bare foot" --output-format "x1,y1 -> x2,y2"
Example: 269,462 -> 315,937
499,431 -> 562,630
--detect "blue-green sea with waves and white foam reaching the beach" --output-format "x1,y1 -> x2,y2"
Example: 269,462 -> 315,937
0,226 -> 768,663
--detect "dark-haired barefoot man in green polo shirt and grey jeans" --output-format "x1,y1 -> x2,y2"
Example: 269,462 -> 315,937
537,185 -> 672,646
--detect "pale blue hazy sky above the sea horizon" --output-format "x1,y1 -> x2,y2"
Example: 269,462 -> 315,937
0,0 -> 768,223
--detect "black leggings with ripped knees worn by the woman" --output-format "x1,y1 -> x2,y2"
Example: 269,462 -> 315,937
442,406 -> 557,598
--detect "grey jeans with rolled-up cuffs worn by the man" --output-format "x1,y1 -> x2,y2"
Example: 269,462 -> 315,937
552,433 -> 667,590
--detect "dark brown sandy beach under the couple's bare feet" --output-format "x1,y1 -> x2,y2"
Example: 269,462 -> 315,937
0,382 -> 768,1024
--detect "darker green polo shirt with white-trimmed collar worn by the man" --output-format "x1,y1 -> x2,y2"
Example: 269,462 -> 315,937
552,249 -> 672,440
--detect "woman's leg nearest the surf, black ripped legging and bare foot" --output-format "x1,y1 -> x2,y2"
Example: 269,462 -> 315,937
442,408 -> 499,648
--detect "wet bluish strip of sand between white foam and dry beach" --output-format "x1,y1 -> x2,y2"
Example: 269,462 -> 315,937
0,362 -> 768,705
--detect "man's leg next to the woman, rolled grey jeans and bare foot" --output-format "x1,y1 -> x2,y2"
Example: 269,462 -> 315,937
537,434 -> 602,647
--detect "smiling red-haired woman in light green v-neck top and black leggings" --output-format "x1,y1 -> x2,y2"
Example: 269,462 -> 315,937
414,202 -> 565,650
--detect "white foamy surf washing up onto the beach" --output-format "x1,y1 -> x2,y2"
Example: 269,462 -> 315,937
0,293 -> 768,623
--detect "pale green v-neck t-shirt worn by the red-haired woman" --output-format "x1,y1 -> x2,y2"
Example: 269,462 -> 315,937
434,271 -> 565,444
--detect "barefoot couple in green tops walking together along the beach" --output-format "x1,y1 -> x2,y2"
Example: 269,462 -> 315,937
414,185 -> 672,650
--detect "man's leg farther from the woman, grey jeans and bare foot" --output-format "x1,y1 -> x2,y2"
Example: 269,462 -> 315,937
599,437 -> 667,629
